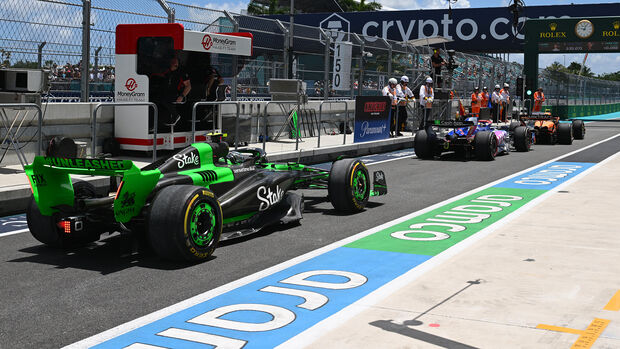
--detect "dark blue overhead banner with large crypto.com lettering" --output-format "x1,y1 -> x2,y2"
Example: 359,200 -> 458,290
269,3 -> 620,52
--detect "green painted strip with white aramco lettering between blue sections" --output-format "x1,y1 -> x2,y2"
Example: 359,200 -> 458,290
346,187 -> 546,256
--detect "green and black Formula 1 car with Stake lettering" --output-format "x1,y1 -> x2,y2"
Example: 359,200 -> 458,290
25,137 -> 387,261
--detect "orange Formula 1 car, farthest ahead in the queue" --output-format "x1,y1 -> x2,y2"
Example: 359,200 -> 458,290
510,112 -> 586,144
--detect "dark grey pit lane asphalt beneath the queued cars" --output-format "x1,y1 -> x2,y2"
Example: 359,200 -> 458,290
0,123 -> 620,348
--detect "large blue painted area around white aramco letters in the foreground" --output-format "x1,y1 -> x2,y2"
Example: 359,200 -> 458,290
95,247 -> 431,349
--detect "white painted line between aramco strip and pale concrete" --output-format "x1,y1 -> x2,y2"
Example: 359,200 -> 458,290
276,147 -> 620,349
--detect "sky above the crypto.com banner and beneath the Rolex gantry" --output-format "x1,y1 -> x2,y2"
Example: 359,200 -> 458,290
192,0 -> 620,74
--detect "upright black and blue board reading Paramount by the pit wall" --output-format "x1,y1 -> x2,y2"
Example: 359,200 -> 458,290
353,96 -> 391,143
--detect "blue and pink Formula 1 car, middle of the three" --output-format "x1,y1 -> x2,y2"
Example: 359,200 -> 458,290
413,117 -> 532,160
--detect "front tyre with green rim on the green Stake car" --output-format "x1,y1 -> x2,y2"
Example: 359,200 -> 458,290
327,159 -> 370,213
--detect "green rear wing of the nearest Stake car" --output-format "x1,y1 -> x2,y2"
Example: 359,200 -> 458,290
24,156 -> 161,222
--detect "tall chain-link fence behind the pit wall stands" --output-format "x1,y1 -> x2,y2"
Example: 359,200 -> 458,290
0,0 -> 620,104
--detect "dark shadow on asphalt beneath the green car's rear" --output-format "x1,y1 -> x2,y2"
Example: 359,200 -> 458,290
8,235 -> 216,275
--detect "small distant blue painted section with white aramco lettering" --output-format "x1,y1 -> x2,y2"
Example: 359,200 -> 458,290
494,162 -> 596,190
